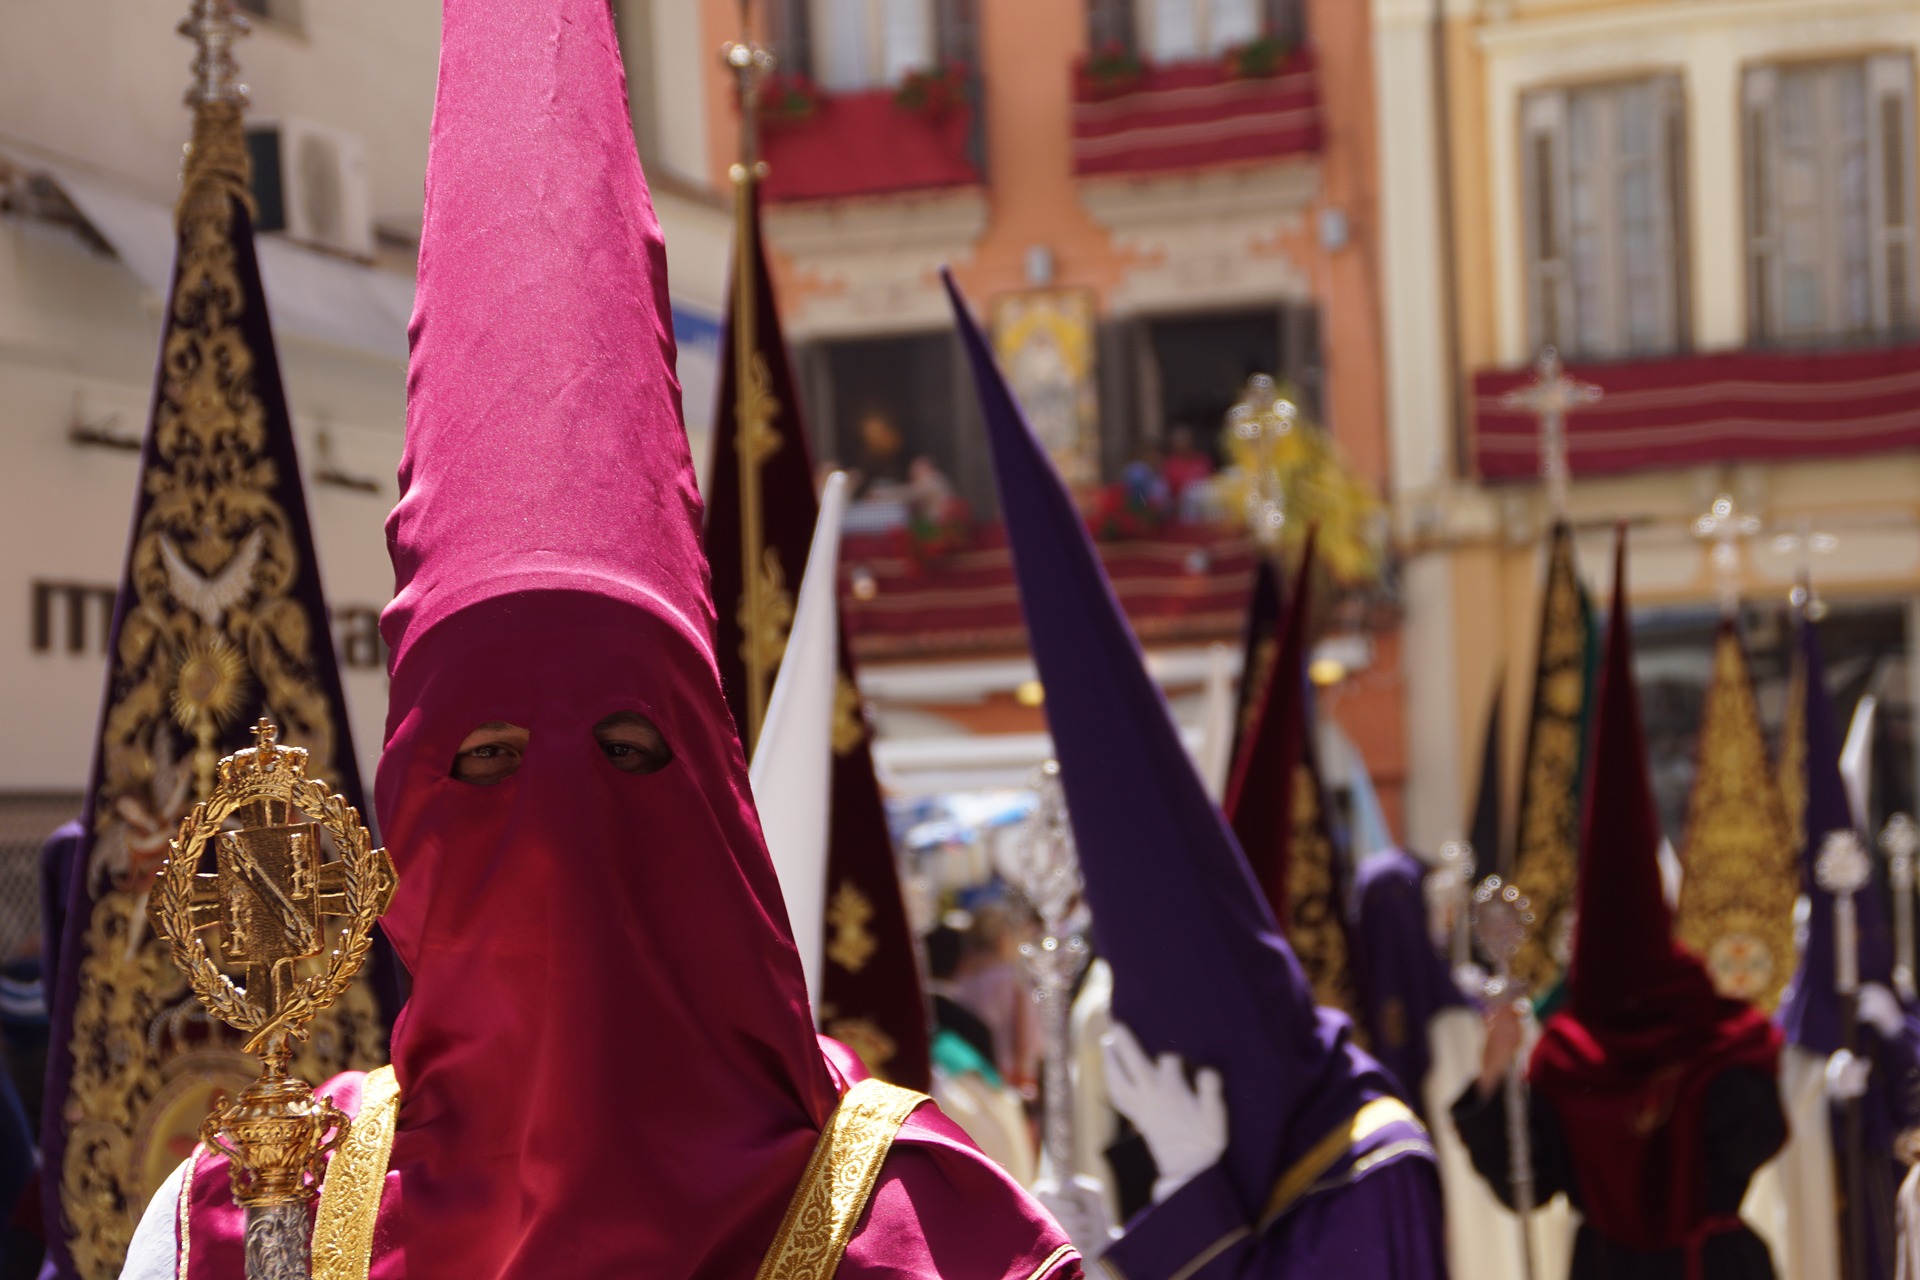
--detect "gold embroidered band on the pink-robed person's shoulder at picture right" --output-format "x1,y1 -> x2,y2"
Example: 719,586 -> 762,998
752,1080 -> 927,1280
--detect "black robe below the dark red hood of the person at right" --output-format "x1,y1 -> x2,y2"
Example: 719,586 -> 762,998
1453,1069 -> 1788,1280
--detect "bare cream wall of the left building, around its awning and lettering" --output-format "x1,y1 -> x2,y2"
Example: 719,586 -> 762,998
0,0 -> 728,793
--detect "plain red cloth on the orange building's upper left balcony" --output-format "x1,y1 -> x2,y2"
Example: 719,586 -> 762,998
760,69 -> 983,201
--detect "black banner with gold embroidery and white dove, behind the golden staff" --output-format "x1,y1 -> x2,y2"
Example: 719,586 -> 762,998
42,102 -> 386,1280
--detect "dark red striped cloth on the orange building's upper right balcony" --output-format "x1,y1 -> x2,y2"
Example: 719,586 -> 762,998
1073,48 -> 1321,177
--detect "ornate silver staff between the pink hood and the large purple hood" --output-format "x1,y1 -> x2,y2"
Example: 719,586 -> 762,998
1006,760 -> 1091,1184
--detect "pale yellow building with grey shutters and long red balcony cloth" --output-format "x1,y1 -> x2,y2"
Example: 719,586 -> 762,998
1371,0 -> 1920,855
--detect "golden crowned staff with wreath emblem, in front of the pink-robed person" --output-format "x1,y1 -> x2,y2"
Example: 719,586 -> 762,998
148,718 -> 396,1280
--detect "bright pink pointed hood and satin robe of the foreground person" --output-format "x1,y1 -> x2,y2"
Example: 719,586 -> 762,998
188,0 -> 1073,1280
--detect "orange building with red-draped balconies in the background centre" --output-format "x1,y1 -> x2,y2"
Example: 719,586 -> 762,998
691,0 -> 1405,816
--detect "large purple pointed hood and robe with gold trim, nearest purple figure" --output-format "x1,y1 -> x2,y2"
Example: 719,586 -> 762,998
947,276 -> 1446,1280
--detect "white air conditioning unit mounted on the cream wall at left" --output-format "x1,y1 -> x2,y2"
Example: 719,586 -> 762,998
246,119 -> 372,259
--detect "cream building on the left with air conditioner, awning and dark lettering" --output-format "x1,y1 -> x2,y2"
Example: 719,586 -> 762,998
0,0 -> 730,956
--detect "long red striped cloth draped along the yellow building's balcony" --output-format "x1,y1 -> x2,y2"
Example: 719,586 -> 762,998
1473,344 -> 1920,480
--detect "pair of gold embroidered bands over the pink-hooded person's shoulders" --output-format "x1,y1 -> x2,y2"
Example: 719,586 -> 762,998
297,1067 -> 927,1280
